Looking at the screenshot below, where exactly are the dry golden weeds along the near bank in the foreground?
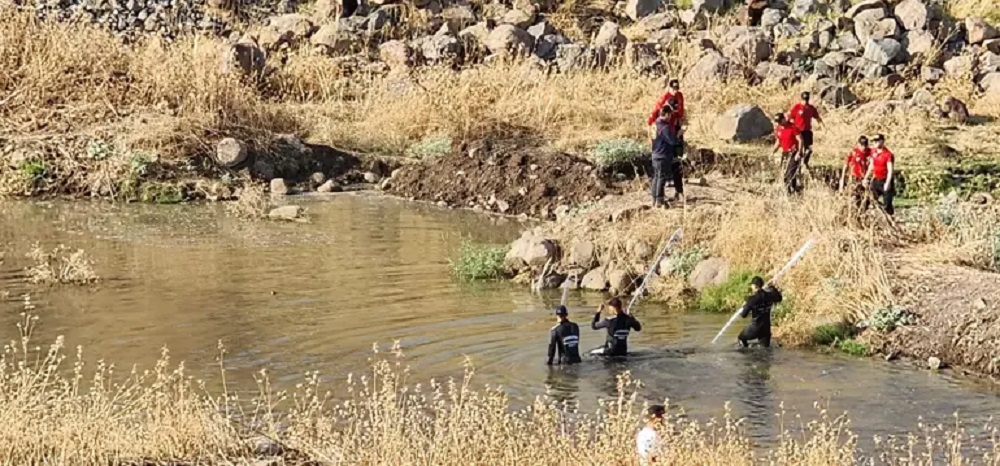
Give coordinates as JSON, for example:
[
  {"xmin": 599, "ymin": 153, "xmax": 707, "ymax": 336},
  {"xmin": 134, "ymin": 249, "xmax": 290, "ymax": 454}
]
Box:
[{"xmin": 0, "ymin": 297, "xmax": 1000, "ymax": 466}]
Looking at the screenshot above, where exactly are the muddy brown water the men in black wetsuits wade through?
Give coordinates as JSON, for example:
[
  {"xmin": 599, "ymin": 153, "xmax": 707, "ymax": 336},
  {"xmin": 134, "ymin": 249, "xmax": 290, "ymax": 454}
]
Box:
[{"xmin": 0, "ymin": 194, "xmax": 1000, "ymax": 443}]
